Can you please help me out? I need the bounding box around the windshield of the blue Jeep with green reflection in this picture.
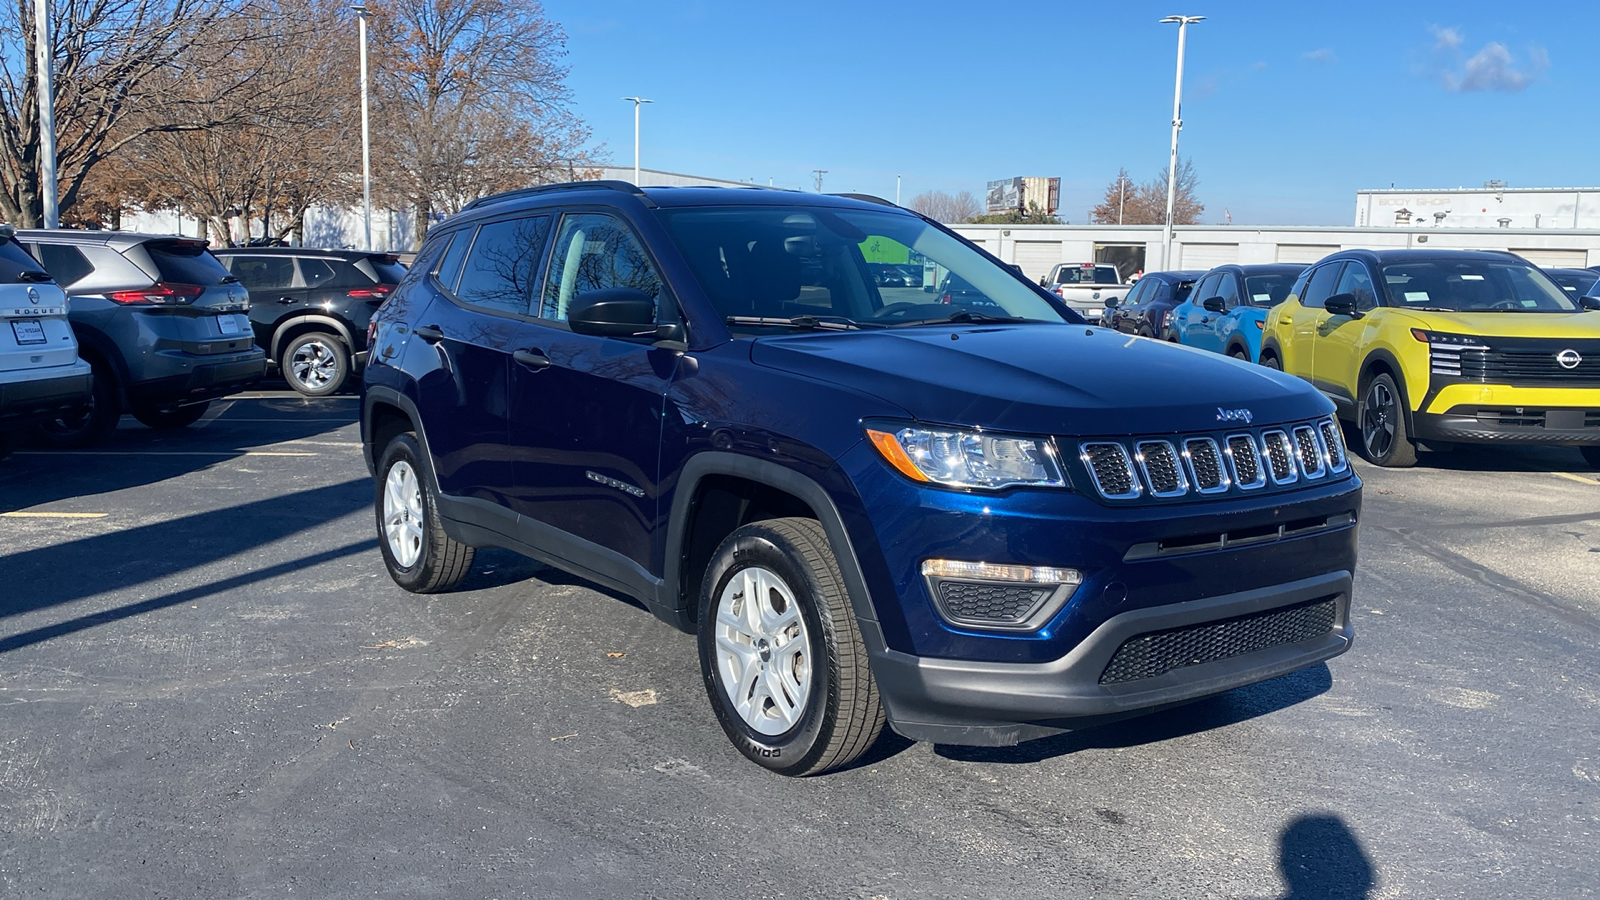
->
[661,207,1069,330]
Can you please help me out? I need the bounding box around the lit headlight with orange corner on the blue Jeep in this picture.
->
[867,426,1067,490]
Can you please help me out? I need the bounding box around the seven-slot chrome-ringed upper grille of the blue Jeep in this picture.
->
[1078,418,1350,501]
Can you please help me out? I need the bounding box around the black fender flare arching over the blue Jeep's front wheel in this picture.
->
[661,450,883,630]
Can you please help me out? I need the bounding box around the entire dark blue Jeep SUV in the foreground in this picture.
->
[362,181,1362,775]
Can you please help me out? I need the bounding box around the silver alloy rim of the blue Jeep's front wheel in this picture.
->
[717,567,811,735]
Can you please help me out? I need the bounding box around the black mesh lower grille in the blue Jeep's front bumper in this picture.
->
[1099,597,1338,684]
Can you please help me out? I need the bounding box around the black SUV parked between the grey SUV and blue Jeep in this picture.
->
[214,247,405,397]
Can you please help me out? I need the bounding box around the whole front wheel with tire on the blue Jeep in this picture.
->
[698,519,885,775]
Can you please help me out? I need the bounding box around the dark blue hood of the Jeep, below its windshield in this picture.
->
[750,325,1333,436]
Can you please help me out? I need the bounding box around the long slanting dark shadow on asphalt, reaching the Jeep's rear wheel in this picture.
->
[0,477,378,652]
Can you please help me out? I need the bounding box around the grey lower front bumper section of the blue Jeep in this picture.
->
[874,572,1354,746]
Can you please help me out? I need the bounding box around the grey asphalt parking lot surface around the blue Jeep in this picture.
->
[0,391,1600,900]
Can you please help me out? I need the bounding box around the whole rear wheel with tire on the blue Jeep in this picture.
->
[373,432,475,594]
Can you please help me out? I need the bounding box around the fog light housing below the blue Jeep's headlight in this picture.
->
[922,559,1083,631]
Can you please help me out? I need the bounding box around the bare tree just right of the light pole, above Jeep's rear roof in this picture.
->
[370,0,589,243]
